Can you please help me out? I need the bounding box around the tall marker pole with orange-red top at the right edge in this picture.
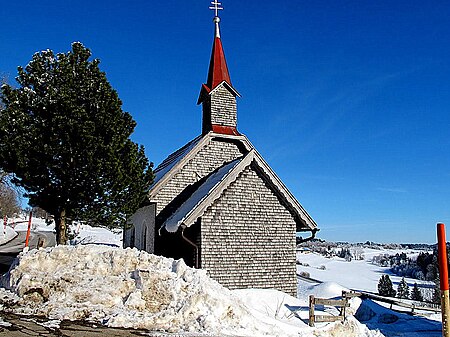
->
[437,223,450,337]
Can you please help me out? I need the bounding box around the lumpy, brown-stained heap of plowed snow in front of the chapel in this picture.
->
[0,245,264,333]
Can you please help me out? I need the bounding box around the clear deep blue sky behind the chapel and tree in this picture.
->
[0,0,450,243]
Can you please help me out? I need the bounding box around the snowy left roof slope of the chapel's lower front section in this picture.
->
[162,158,242,233]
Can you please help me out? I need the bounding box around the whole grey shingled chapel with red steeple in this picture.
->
[124,9,318,295]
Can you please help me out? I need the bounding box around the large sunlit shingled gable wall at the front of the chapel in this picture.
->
[201,166,297,296]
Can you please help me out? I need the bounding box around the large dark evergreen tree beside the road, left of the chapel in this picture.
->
[0,42,153,244]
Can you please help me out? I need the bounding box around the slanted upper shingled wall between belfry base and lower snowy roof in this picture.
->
[154,139,246,214]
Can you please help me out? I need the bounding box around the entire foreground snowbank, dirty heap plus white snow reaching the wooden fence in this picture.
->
[0,245,380,337]
